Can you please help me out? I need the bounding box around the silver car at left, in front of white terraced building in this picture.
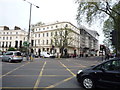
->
[2,51,23,62]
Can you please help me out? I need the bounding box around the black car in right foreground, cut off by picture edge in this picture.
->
[76,58,120,90]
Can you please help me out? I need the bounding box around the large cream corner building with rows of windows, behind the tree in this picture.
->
[31,22,80,54]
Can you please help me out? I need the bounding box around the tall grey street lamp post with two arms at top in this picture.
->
[24,0,39,60]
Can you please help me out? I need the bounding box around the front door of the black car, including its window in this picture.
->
[94,60,115,86]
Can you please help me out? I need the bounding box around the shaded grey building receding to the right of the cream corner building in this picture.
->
[80,27,99,56]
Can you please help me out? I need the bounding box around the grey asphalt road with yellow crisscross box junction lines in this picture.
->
[0,57,101,90]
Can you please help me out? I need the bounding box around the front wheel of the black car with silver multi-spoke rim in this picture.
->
[82,77,95,90]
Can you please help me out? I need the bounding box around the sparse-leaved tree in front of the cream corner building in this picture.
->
[52,27,74,57]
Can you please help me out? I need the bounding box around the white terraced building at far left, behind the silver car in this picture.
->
[0,26,27,51]
